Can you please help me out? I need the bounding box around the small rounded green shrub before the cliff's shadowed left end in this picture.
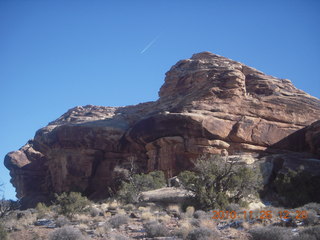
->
[56,192,90,218]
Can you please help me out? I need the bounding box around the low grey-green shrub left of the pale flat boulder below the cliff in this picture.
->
[117,171,166,203]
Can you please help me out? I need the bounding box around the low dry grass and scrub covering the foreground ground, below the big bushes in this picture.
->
[0,195,320,240]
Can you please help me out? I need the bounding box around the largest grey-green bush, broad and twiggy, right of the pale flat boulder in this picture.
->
[178,155,262,209]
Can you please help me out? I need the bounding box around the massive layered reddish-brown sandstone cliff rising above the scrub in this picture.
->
[5,52,320,206]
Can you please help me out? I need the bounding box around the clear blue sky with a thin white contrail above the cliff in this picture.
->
[0,0,320,198]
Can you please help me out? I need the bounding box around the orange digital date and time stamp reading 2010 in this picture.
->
[212,210,308,220]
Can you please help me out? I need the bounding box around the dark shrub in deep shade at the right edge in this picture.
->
[274,169,320,208]
